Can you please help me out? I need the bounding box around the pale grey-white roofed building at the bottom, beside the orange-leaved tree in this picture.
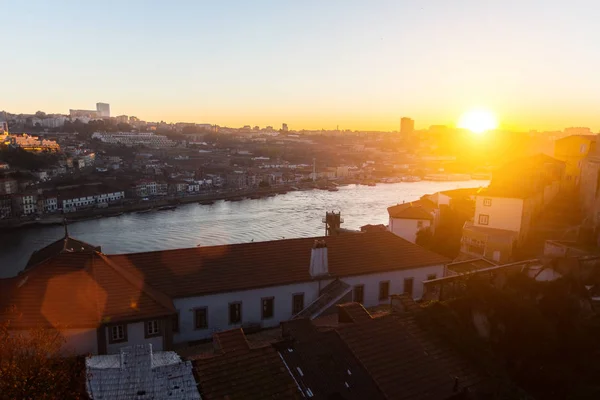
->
[85,345,200,400]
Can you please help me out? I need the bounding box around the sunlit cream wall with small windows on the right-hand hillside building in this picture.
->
[473,196,523,232]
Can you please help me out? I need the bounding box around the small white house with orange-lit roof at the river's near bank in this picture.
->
[388,199,439,243]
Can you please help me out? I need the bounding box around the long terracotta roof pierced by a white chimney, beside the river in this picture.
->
[107,232,450,298]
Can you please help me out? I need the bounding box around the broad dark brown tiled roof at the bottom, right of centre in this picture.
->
[336,308,480,400]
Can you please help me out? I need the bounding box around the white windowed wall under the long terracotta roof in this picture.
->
[173,265,444,343]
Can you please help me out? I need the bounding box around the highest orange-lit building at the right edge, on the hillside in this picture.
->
[554,135,596,190]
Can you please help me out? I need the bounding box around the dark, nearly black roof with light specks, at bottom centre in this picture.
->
[274,319,384,400]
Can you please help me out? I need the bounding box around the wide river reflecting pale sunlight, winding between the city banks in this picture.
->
[0,180,488,278]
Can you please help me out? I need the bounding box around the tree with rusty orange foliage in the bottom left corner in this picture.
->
[0,321,86,400]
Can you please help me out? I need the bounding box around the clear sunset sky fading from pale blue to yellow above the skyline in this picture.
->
[0,0,600,131]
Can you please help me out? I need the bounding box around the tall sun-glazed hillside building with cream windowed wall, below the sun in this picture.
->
[461,154,565,263]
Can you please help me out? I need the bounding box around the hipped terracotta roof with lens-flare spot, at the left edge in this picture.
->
[0,252,175,328]
